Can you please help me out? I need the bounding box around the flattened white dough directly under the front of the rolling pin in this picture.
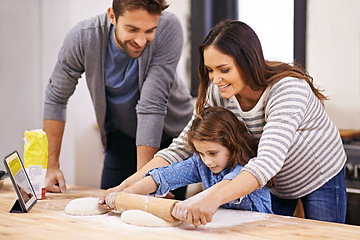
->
[121,209,182,227]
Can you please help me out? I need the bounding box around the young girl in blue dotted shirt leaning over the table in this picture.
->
[105,107,272,221]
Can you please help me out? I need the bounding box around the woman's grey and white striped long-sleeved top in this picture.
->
[156,77,346,199]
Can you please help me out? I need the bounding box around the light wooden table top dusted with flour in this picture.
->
[0,179,360,240]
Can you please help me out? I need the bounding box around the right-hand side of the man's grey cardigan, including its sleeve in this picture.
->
[136,12,193,147]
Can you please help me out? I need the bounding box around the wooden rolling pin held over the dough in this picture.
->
[115,192,179,222]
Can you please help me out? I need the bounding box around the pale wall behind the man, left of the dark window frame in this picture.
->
[0,0,190,187]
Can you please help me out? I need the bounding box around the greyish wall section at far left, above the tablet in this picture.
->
[0,0,43,169]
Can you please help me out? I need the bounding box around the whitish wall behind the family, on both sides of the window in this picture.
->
[0,0,360,187]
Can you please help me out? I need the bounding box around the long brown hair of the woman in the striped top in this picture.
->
[196,20,327,114]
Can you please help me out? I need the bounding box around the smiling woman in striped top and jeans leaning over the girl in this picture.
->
[100,20,346,224]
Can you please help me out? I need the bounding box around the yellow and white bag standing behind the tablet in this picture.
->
[24,129,48,199]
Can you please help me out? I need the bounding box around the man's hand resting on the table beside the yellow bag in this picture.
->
[46,168,66,193]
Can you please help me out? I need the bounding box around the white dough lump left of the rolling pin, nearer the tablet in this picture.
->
[64,197,108,216]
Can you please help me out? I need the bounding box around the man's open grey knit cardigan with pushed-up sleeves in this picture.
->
[44,12,194,147]
